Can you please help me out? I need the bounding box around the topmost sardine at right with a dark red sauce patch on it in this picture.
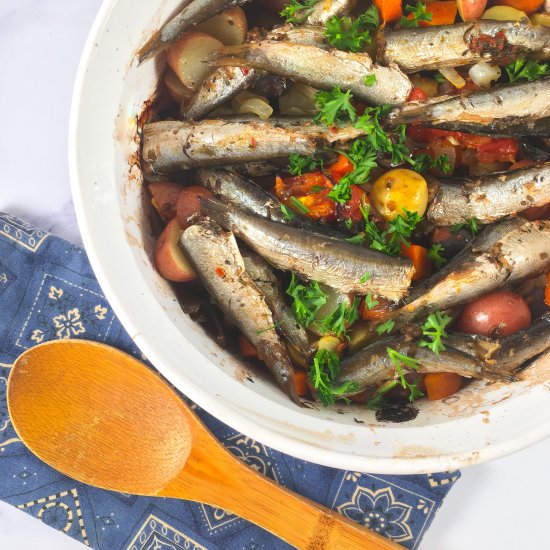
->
[376,20,550,73]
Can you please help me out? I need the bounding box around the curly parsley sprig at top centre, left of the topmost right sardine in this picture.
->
[325,6,380,52]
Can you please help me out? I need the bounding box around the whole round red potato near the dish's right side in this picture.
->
[458,290,531,338]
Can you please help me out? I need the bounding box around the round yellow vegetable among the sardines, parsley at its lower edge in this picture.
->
[369,168,428,221]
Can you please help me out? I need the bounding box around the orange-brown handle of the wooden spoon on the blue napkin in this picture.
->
[159,432,402,550]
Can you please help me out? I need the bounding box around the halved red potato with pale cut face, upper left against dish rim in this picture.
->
[167,31,223,91]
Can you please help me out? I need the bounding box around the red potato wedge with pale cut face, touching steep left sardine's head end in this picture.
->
[155,218,197,283]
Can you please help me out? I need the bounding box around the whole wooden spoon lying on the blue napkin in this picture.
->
[7,340,401,550]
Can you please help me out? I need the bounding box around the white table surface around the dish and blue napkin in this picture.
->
[0,0,550,550]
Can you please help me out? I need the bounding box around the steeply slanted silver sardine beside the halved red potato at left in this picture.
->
[180,221,300,403]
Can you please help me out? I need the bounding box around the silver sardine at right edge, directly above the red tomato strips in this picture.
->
[387,78,550,136]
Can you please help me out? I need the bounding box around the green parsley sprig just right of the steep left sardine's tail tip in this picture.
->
[309,349,359,406]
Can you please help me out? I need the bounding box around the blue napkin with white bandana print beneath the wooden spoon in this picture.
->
[0,214,460,550]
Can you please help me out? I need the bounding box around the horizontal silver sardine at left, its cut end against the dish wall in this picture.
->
[141,117,364,180]
